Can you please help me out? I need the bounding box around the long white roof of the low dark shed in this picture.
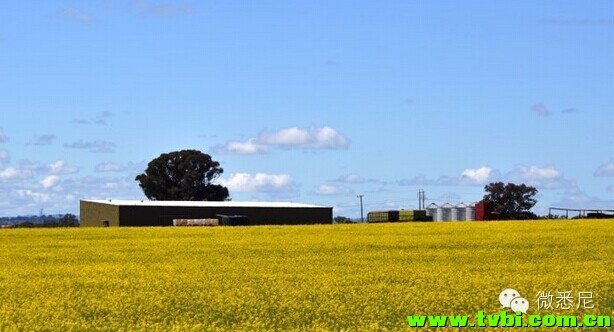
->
[81,199,330,208]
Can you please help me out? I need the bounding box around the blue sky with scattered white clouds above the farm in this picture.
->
[0,0,614,217]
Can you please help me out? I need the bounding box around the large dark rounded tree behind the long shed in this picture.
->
[135,150,229,201]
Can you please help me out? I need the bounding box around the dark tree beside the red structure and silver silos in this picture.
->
[482,182,537,219]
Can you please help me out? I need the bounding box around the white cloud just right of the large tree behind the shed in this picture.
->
[220,173,296,193]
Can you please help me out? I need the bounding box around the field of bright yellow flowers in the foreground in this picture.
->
[0,220,614,331]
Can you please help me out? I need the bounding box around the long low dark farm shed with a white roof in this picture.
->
[80,200,333,227]
